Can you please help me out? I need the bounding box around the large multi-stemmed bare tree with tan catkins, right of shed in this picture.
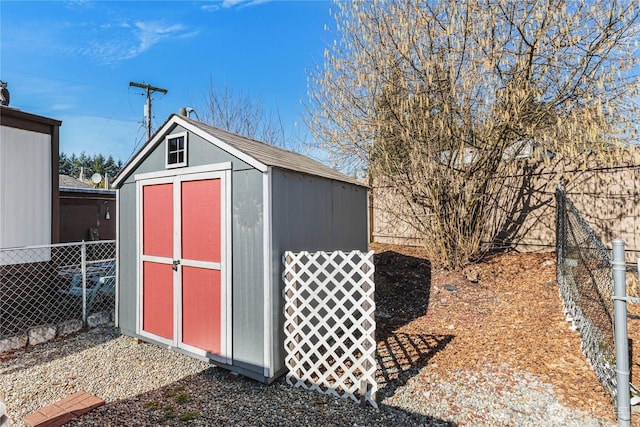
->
[309,0,640,268]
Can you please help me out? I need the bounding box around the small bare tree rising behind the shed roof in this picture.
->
[202,82,289,147]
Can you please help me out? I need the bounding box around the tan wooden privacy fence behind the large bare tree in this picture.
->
[369,164,640,262]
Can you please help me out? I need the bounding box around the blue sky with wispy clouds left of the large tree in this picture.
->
[0,0,333,161]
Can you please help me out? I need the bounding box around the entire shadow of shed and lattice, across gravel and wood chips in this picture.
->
[67,251,456,427]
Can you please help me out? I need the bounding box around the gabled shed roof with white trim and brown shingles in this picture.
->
[113,114,365,187]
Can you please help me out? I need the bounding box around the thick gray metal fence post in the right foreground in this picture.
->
[611,239,631,427]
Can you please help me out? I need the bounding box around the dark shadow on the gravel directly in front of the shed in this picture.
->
[66,367,455,427]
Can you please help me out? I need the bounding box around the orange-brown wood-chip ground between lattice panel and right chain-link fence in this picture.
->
[371,244,640,426]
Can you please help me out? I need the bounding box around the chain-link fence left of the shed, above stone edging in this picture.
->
[0,240,116,339]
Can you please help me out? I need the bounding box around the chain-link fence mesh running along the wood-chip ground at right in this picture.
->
[556,185,617,401]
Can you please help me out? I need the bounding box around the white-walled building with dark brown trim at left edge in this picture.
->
[0,105,62,256]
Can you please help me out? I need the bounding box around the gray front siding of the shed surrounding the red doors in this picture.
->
[118,126,264,375]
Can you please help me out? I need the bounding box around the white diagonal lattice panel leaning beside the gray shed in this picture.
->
[283,251,378,408]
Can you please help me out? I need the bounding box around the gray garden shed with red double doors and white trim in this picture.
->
[113,114,368,382]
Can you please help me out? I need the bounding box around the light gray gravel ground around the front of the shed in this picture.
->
[0,327,614,427]
